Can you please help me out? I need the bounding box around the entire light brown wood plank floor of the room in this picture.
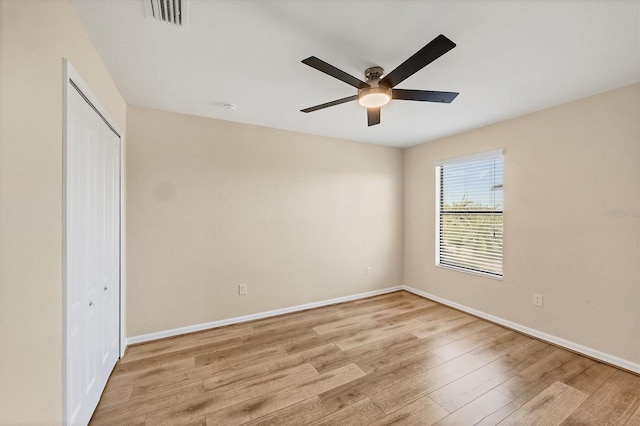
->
[91,291,640,426]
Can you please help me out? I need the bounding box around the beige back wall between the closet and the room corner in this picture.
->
[127,107,403,336]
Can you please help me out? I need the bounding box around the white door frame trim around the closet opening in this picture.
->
[62,58,126,425]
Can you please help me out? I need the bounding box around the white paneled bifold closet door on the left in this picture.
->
[65,80,120,424]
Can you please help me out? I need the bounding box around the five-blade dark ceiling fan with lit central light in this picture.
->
[300,34,458,126]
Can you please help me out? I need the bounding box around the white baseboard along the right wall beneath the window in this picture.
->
[401,285,640,374]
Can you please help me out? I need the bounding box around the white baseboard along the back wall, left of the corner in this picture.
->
[126,286,403,346]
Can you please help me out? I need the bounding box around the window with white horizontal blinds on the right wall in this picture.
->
[436,150,503,277]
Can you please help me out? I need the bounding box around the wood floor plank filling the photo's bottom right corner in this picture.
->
[565,370,640,425]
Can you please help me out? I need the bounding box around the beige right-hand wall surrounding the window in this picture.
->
[403,85,640,363]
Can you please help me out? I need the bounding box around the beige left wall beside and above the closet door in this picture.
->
[0,0,126,424]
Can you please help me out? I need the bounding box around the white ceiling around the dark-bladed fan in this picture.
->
[72,0,640,147]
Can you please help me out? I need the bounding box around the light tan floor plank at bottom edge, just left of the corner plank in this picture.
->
[500,382,589,426]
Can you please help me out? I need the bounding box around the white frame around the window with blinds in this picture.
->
[434,149,504,281]
